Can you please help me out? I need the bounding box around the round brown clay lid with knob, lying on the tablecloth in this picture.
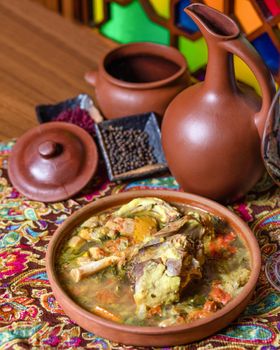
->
[8,122,98,202]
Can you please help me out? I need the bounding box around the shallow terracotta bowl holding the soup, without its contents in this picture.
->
[47,191,261,346]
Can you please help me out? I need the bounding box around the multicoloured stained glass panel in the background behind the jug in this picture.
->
[92,0,280,91]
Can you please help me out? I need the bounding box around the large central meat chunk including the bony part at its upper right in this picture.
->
[128,213,218,317]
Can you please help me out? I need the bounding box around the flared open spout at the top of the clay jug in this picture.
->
[185,4,240,41]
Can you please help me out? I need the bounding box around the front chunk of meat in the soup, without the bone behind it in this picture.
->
[128,234,201,313]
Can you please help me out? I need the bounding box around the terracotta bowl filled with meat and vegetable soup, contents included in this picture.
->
[47,191,260,346]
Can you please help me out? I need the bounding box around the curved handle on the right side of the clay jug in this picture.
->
[220,35,276,138]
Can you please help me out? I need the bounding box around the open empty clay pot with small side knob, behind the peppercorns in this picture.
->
[85,43,190,119]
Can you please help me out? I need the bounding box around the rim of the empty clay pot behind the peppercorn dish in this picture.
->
[99,42,188,89]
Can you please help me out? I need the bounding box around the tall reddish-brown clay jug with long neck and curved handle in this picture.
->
[162,4,275,202]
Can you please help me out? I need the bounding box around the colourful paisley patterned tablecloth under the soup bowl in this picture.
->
[0,141,280,350]
